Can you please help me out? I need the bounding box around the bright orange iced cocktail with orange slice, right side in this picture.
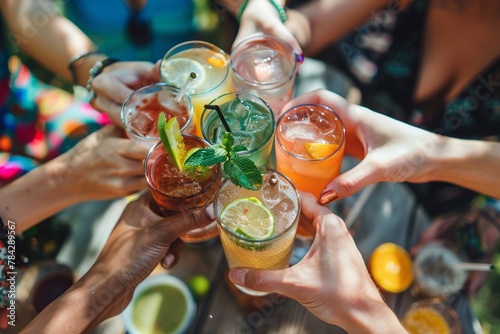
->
[275,104,345,198]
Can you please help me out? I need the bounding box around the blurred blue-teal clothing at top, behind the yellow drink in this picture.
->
[65,0,196,63]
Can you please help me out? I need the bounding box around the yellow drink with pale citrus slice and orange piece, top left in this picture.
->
[160,41,232,137]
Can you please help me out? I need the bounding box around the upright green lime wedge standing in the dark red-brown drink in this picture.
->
[158,112,185,170]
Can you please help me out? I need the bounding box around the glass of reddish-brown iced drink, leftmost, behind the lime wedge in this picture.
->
[121,83,194,147]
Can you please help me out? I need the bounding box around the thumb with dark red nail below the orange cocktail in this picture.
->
[319,159,382,204]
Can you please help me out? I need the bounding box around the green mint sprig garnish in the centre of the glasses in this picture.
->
[184,132,262,190]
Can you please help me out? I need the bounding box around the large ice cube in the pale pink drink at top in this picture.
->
[251,49,285,83]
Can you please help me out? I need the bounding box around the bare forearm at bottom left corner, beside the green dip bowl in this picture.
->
[22,267,131,333]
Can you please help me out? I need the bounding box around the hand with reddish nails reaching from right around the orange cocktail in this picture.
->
[282,89,442,204]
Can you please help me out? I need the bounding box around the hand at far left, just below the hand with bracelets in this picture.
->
[54,126,148,201]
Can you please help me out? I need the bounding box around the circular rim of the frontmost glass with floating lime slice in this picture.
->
[213,167,302,244]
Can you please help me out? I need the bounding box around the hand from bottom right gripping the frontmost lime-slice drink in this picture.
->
[229,193,399,333]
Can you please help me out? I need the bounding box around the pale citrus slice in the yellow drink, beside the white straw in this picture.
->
[161,58,206,89]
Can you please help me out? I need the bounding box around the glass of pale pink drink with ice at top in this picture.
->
[230,35,297,118]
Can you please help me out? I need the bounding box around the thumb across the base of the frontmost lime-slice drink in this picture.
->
[229,267,286,294]
